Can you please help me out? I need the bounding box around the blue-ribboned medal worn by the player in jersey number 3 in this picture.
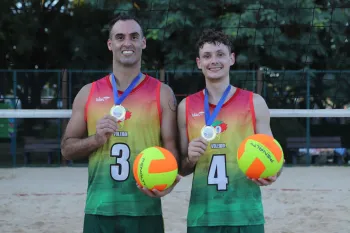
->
[110,72,142,121]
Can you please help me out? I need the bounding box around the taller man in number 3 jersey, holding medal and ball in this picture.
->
[62,16,179,233]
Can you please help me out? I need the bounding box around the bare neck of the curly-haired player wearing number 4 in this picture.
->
[205,78,235,104]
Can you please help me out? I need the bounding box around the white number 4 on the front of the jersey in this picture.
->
[208,155,228,191]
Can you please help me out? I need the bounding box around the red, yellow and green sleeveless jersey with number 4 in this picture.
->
[186,88,264,227]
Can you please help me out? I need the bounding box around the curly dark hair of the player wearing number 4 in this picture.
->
[197,29,233,53]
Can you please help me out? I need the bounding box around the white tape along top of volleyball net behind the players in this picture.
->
[0,109,350,119]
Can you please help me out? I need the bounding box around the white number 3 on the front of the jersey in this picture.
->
[111,143,130,181]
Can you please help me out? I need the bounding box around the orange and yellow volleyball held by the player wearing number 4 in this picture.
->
[237,134,284,179]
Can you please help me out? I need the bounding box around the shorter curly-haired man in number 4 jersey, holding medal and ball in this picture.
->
[178,30,284,233]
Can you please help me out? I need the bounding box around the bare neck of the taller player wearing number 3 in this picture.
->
[111,64,141,91]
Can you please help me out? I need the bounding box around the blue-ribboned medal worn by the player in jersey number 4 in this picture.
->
[201,85,231,141]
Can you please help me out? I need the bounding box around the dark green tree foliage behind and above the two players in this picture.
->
[0,0,350,111]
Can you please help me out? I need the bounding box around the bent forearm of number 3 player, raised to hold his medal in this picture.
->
[61,135,101,160]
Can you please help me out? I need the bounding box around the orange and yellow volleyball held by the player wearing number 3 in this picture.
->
[133,146,178,191]
